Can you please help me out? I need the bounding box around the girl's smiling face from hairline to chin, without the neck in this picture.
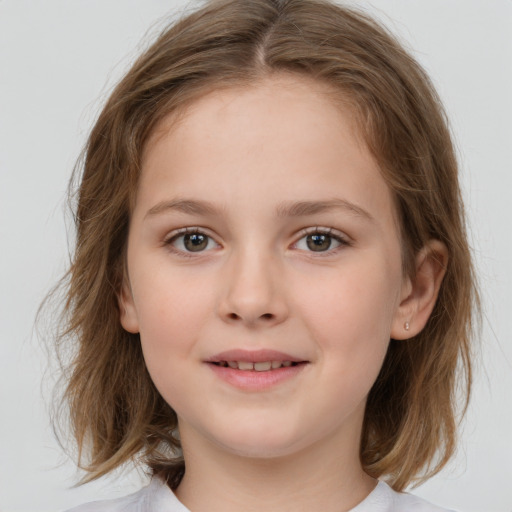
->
[121,77,409,457]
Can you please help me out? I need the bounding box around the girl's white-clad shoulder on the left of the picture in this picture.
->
[62,478,189,512]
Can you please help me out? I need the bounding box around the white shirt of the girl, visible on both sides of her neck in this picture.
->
[68,478,453,512]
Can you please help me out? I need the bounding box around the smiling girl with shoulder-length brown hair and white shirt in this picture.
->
[59,0,476,512]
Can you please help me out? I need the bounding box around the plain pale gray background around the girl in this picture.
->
[0,0,512,512]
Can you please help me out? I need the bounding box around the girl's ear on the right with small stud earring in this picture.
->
[391,240,448,340]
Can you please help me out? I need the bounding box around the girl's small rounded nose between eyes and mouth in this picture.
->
[219,248,288,328]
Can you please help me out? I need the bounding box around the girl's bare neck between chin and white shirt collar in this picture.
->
[176,422,376,512]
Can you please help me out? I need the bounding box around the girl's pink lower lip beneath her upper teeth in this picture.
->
[207,363,307,391]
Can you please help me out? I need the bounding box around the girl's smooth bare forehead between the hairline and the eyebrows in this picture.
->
[139,75,391,228]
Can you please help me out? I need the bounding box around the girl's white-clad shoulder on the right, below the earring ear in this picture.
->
[350,482,454,512]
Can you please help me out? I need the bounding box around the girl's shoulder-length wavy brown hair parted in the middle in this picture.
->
[58,0,478,490]
